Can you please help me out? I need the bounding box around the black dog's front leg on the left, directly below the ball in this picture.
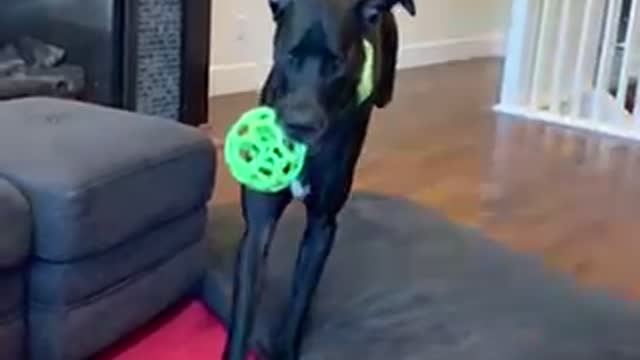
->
[222,189,291,360]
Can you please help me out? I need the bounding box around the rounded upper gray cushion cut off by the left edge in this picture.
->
[0,179,31,268]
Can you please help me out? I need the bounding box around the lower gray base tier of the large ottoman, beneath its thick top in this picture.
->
[29,241,206,360]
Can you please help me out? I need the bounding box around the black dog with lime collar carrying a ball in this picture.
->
[223,0,415,360]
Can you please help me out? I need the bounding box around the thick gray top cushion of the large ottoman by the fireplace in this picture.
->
[0,98,215,261]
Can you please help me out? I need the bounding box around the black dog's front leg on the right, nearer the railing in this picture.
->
[273,215,336,360]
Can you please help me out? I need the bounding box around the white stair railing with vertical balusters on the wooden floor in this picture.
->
[496,0,640,140]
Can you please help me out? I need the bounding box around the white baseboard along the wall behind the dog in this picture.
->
[209,33,504,96]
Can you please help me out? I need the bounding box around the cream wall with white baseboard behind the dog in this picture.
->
[211,0,511,95]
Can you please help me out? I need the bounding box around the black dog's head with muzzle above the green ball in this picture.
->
[262,0,415,146]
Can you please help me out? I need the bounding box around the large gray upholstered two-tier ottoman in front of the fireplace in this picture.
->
[0,98,216,360]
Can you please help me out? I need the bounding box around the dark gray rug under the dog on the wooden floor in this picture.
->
[202,194,640,360]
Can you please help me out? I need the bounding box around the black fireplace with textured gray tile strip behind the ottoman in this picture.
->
[0,0,210,125]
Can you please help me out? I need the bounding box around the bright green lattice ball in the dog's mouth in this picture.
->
[224,107,307,193]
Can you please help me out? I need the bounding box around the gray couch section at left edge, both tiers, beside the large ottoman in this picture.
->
[0,179,31,360]
